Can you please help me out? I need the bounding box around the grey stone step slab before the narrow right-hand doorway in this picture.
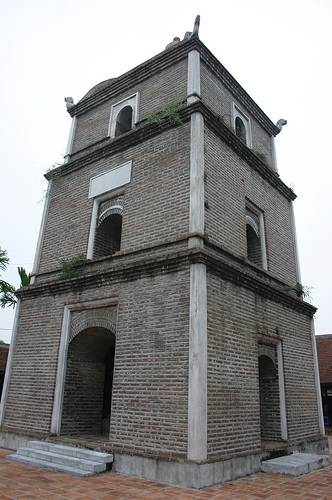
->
[261,453,330,476]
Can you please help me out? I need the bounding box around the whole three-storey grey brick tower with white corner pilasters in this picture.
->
[0,17,327,486]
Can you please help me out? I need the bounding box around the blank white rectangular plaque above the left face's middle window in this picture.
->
[89,161,132,198]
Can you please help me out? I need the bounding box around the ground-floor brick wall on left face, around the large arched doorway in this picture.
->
[4,269,189,456]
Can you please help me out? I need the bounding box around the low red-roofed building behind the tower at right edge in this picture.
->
[316,335,332,427]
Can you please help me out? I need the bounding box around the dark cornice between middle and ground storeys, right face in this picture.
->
[189,249,317,317]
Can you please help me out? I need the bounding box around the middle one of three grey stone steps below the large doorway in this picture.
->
[16,447,106,474]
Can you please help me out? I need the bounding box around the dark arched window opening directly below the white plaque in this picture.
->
[94,213,122,258]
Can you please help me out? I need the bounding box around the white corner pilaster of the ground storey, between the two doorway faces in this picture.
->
[188,263,207,460]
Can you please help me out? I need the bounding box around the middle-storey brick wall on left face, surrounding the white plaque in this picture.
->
[40,123,190,272]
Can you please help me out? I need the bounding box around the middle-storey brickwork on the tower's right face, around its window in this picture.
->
[205,127,296,286]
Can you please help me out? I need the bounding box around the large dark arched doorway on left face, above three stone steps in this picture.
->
[61,327,115,436]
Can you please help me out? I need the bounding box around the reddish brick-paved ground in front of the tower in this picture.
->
[0,438,332,500]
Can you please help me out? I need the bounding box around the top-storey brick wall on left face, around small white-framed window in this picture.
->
[73,59,187,152]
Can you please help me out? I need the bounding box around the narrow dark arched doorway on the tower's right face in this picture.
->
[258,355,281,441]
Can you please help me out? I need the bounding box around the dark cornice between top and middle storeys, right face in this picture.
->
[191,102,296,200]
